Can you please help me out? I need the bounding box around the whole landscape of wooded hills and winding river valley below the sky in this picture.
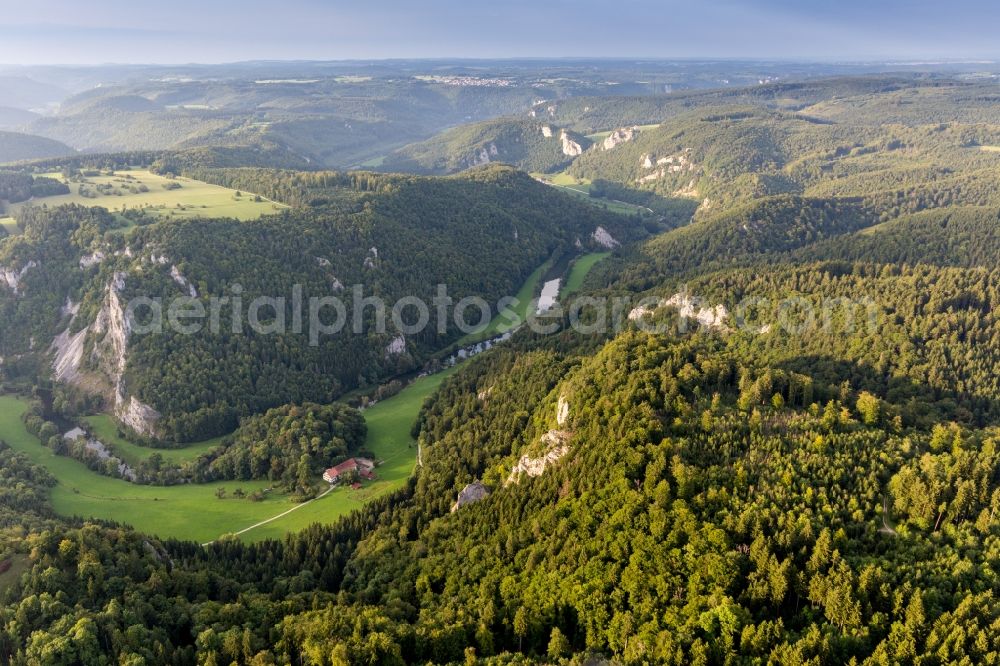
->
[0,59,1000,666]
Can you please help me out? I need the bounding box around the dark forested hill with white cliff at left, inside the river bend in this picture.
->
[0,166,638,440]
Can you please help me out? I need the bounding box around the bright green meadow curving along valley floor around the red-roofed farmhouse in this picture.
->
[0,370,453,543]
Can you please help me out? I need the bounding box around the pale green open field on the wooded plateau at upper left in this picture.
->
[10,170,286,220]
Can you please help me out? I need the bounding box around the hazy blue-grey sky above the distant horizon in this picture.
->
[0,0,1000,63]
